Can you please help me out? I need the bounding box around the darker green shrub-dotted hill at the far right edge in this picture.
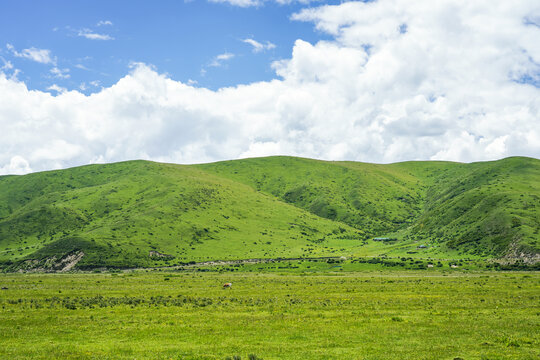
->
[402,158,540,256]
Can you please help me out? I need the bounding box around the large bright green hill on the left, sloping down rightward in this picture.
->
[0,161,365,267]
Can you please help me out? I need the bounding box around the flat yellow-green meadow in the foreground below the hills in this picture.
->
[0,265,540,360]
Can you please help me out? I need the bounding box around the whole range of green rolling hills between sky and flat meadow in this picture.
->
[0,156,540,269]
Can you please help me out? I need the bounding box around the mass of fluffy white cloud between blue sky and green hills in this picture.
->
[0,0,540,174]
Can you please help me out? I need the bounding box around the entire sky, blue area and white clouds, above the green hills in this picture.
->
[0,0,540,175]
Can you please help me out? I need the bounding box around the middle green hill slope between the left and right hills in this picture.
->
[198,156,460,236]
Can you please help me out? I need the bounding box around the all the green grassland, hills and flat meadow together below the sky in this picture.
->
[0,157,540,360]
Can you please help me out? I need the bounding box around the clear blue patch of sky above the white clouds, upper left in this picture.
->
[0,0,342,93]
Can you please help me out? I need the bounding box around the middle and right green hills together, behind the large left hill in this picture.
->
[199,157,540,257]
